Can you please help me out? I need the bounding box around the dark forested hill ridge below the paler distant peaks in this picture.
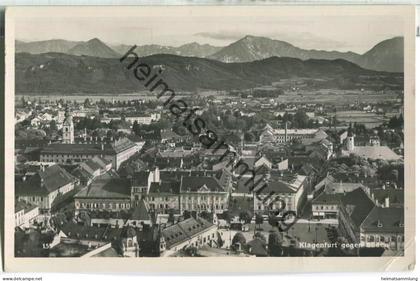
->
[15,53,403,94]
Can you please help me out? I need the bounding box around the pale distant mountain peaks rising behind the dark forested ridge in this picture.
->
[16,35,404,72]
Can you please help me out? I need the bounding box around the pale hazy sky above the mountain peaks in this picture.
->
[15,15,403,53]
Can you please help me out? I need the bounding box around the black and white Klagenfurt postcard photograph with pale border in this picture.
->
[5,4,414,270]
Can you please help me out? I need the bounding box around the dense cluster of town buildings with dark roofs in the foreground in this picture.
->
[15,95,404,257]
